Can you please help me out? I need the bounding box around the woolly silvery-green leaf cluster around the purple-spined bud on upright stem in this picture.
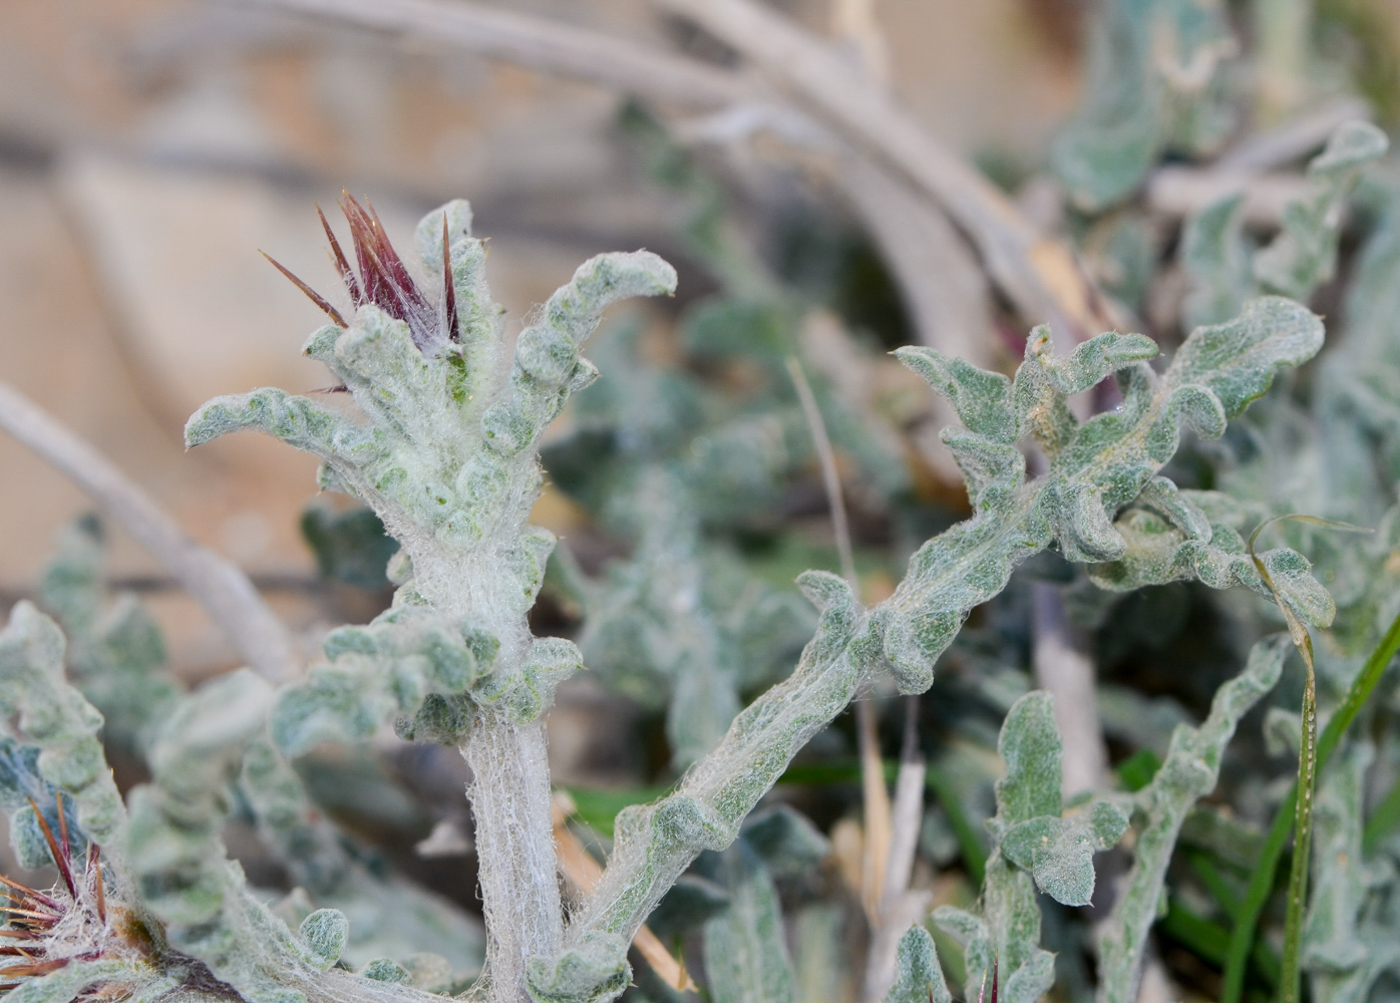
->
[186,202,676,795]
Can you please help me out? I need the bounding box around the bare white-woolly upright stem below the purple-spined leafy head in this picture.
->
[461,713,564,1003]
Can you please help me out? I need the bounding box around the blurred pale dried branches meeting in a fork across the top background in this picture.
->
[235,0,1112,340]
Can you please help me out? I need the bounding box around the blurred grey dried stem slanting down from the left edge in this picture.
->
[0,384,297,682]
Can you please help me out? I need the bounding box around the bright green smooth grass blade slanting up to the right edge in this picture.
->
[1221,607,1400,1003]
